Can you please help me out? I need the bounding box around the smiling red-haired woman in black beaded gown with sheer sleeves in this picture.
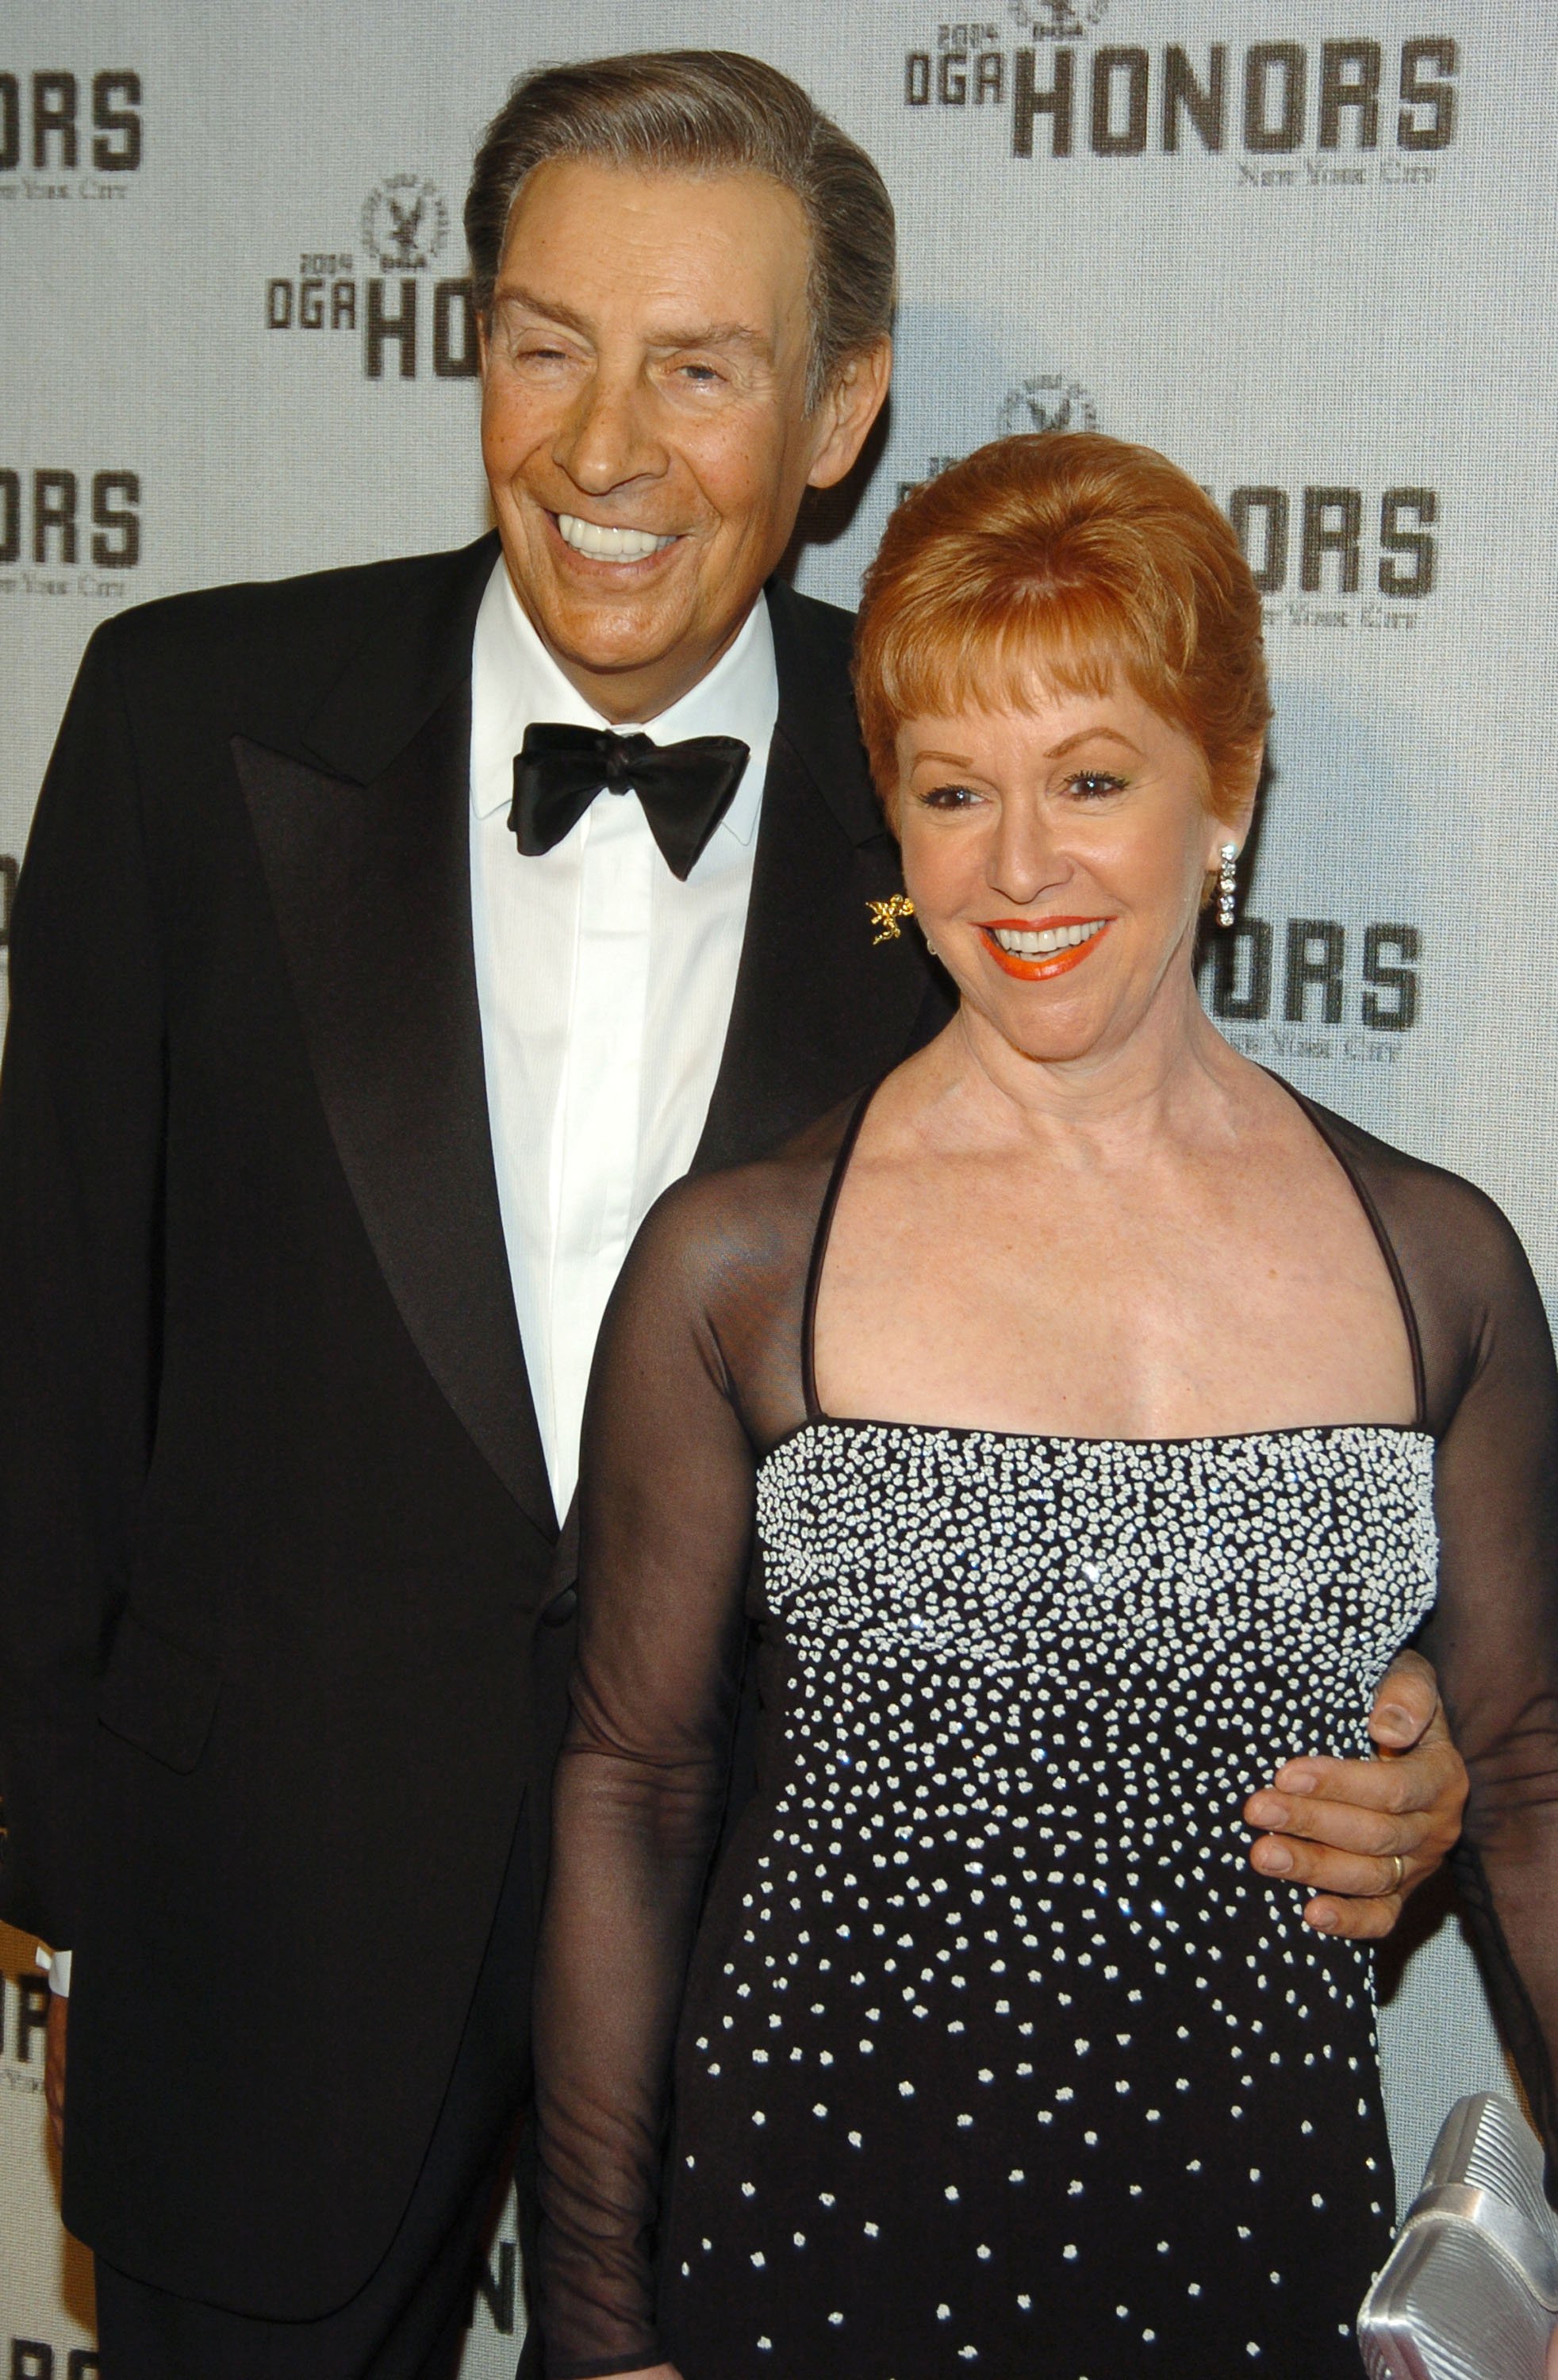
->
[538,438,1558,2380]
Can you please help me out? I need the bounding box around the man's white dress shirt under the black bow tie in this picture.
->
[471,559,778,1518]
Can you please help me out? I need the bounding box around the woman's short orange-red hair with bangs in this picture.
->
[854,431,1270,819]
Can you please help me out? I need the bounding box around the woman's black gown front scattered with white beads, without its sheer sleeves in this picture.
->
[669,1421,1437,2380]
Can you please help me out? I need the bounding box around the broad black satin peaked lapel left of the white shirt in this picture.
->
[233,681,557,1537]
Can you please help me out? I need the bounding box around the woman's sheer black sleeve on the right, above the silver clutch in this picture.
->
[1318,1119,1558,2202]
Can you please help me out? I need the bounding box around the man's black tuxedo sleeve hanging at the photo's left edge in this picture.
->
[0,624,164,1944]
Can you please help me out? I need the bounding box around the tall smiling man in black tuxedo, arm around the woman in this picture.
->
[0,55,1458,2380]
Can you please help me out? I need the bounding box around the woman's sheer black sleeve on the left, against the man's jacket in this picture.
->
[535,1128,837,2380]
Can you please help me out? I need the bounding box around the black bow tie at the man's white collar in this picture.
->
[509,724,747,883]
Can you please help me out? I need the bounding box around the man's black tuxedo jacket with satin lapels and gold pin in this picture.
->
[0,538,946,2318]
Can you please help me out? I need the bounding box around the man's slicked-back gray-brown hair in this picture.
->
[466,50,894,407]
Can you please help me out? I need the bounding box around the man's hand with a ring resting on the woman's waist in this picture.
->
[1244,1652,1468,1942]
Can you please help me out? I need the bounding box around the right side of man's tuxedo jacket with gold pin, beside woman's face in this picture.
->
[695,588,949,1171]
